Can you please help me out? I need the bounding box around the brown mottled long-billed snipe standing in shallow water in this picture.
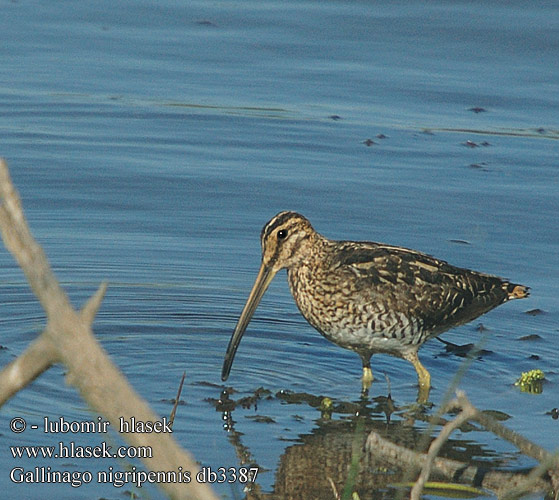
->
[221,212,529,398]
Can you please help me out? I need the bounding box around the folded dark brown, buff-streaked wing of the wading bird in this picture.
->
[331,242,507,331]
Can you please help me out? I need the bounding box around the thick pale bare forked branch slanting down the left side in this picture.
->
[0,160,217,500]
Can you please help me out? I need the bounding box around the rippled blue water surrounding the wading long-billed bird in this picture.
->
[0,0,559,498]
